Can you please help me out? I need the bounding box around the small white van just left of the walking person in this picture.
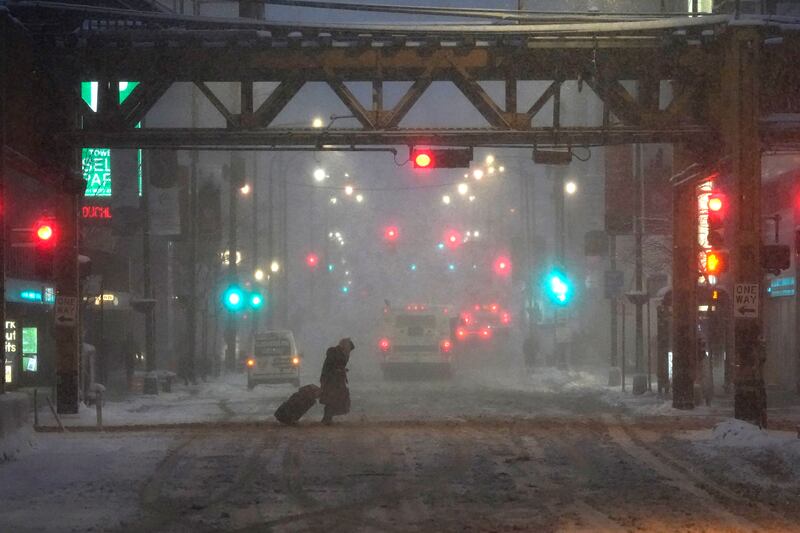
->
[246,330,302,389]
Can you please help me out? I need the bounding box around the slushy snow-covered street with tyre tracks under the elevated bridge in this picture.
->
[0,366,800,532]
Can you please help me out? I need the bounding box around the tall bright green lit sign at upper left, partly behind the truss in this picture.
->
[81,81,142,197]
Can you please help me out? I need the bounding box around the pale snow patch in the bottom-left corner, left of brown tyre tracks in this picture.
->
[0,433,173,533]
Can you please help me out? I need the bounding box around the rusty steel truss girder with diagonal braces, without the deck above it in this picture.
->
[61,38,711,147]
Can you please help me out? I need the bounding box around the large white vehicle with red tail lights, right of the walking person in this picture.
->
[378,304,453,378]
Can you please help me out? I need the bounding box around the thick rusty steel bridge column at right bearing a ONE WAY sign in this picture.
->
[720,28,767,427]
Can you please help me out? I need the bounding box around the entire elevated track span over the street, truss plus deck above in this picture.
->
[14,2,800,150]
